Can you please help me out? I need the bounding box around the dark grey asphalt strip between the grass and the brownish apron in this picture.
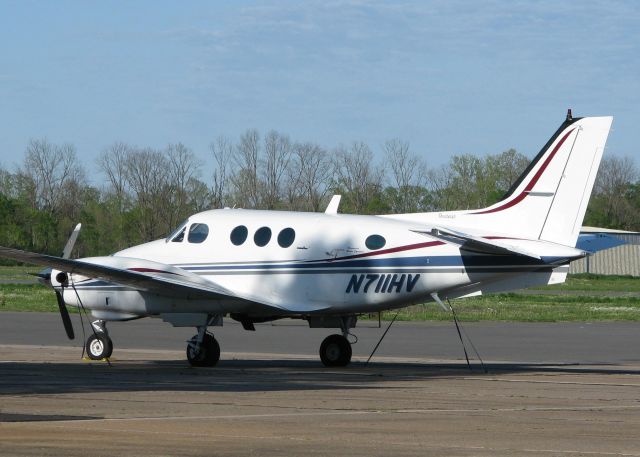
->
[0,312,640,364]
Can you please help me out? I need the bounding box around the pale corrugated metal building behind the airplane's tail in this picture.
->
[569,227,640,276]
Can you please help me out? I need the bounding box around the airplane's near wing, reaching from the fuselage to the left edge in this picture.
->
[0,246,322,313]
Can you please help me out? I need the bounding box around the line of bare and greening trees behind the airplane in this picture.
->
[0,129,640,256]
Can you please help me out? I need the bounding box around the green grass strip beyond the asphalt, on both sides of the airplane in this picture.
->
[0,266,640,322]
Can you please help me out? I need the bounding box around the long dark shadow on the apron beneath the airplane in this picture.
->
[0,360,640,396]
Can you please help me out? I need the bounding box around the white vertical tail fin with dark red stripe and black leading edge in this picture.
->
[464,114,613,246]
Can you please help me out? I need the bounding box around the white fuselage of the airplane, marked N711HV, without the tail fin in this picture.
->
[54,209,576,316]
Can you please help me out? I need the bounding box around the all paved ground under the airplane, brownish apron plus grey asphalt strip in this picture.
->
[0,313,640,456]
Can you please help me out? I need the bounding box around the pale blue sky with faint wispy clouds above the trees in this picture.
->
[0,0,640,176]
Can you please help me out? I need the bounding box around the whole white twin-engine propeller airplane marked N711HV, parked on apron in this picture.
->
[0,111,612,366]
